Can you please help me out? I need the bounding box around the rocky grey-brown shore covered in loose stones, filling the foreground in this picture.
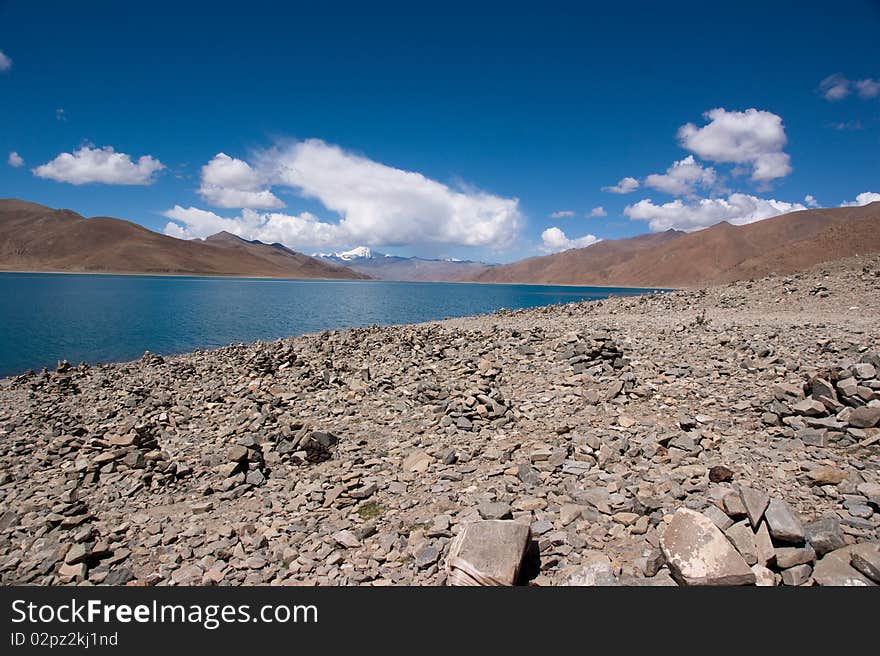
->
[0,257,880,585]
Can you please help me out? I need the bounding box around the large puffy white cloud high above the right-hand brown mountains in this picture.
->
[678,107,791,182]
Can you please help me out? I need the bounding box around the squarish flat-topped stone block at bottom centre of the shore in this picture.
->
[446,519,531,586]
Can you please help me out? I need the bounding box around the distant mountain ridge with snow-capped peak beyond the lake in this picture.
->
[313,246,494,282]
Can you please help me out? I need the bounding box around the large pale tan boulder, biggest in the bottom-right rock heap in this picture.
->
[660,508,755,585]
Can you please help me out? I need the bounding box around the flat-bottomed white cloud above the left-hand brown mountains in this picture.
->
[33,146,165,185]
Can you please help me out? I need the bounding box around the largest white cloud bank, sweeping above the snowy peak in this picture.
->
[165,139,522,249]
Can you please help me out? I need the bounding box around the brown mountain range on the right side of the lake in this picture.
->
[474,202,880,287]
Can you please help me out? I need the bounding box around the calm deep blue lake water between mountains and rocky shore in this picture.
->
[0,273,653,376]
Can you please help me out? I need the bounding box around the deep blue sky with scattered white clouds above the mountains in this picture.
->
[0,0,880,261]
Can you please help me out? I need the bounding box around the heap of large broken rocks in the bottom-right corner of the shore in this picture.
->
[658,486,880,586]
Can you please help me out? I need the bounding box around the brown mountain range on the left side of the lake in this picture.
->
[0,199,368,279]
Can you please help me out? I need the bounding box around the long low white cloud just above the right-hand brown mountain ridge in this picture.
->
[623,194,807,232]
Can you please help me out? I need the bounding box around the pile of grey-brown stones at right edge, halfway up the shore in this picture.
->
[762,353,880,447]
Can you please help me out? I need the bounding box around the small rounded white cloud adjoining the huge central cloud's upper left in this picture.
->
[199,153,284,209]
